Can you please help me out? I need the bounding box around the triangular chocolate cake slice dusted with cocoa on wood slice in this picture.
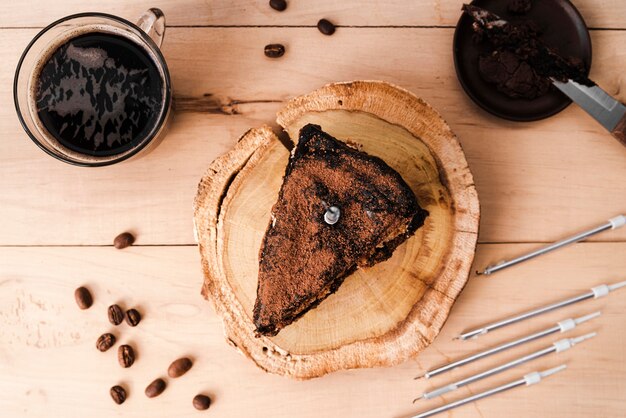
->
[254,125,428,336]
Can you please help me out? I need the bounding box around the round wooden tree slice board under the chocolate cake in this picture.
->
[194,82,479,379]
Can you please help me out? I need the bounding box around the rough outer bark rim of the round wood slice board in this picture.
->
[194,81,480,379]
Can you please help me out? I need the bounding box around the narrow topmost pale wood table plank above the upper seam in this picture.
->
[0,0,626,29]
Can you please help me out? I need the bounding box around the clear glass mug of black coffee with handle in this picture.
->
[13,9,172,167]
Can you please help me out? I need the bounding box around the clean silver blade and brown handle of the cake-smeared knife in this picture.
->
[552,80,626,145]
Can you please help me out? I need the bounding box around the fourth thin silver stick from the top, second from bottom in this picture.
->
[413,332,597,402]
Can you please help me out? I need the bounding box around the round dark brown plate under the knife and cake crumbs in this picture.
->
[453,0,591,121]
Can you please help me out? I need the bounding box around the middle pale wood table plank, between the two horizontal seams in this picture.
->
[0,28,626,245]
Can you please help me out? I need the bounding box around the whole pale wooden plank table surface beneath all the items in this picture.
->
[0,0,626,418]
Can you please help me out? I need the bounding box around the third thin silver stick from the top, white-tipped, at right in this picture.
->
[416,312,601,379]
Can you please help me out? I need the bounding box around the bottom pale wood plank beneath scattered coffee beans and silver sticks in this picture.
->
[0,243,626,418]
